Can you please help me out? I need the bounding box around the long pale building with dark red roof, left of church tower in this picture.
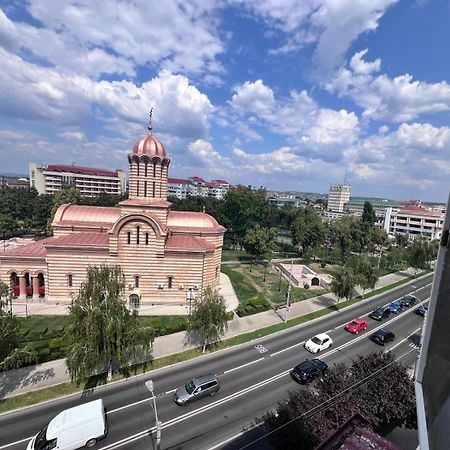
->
[28,162,126,197]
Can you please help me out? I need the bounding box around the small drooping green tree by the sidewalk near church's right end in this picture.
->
[187,286,228,353]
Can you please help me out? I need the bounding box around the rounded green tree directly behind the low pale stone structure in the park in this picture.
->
[291,208,325,256]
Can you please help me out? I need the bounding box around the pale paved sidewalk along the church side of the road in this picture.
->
[0,269,414,399]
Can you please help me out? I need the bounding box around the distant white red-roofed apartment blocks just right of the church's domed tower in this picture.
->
[167,176,233,200]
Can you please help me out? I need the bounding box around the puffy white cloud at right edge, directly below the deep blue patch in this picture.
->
[325,50,450,122]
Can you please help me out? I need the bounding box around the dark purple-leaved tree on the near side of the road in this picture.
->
[263,352,417,450]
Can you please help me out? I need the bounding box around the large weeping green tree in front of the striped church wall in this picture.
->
[66,265,153,383]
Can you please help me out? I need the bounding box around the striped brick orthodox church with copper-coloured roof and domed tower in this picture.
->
[0,121,225,308]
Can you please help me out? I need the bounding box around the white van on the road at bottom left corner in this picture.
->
[27,399,108,450]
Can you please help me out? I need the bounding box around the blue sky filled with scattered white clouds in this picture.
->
[0,0,450,202]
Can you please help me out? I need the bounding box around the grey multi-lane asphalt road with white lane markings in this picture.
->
[0,275,432,450]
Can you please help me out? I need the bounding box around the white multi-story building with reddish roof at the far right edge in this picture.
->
[385,205,445,239]
